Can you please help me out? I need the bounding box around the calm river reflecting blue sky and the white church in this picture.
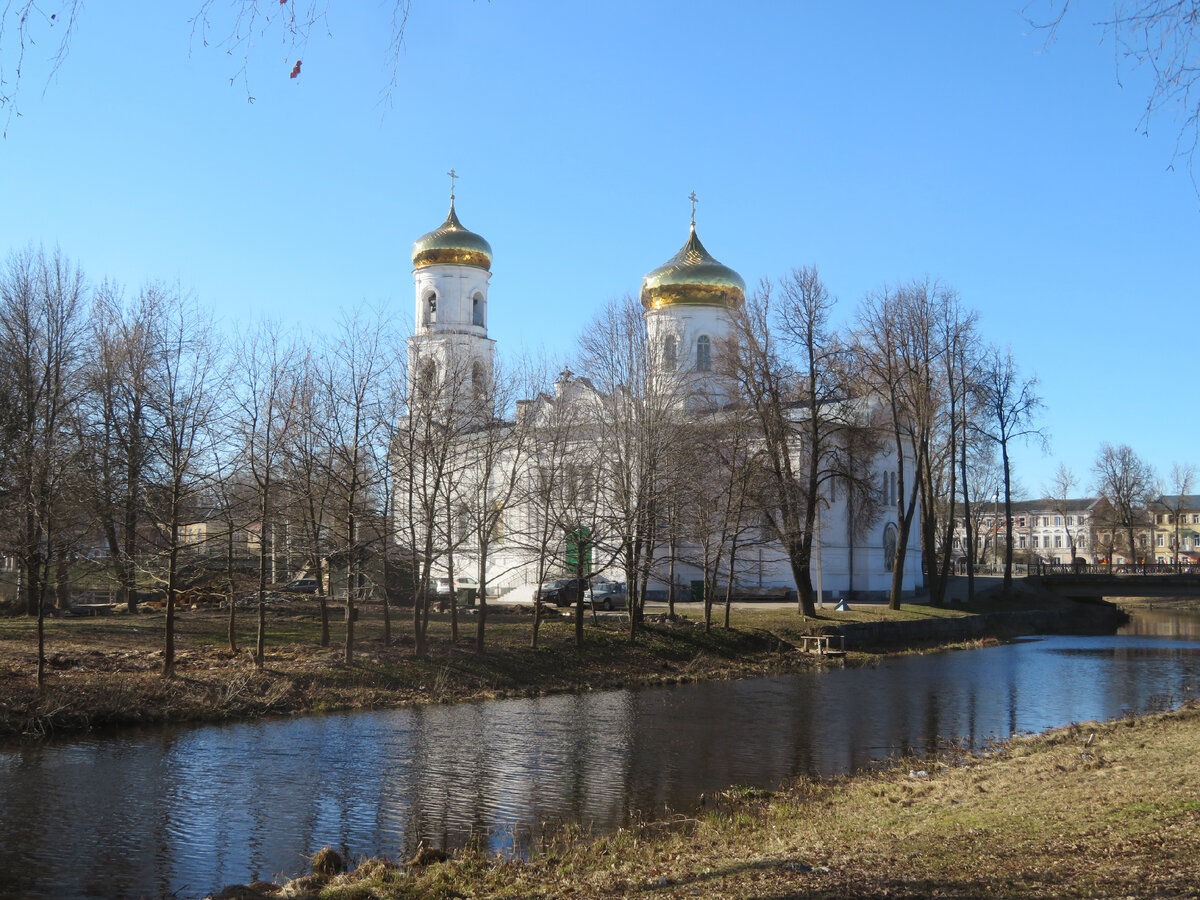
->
[0,611,1200,898]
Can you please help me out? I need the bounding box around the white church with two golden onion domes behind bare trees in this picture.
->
[396,193,922,601]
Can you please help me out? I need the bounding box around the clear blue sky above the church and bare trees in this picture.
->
[0,0,1200,496]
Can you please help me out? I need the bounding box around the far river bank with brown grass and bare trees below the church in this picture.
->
[0,585,1111,738]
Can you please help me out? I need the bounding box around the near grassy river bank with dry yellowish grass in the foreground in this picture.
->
[212,703,1200,900]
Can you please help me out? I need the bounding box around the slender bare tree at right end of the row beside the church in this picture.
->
[976,348,1045,598]
